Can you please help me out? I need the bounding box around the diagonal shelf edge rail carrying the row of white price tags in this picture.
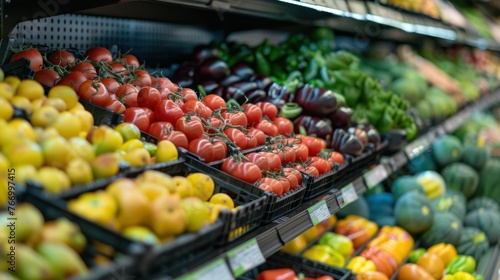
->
[173,90,500,279]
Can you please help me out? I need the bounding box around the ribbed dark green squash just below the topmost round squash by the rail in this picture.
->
[441,162,479,198]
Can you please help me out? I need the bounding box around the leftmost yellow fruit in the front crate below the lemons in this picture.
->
[68,191,118,226]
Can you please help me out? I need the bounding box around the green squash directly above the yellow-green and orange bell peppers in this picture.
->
[421,212,462,248]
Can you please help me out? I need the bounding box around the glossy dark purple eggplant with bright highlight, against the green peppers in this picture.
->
[294,85,337,117]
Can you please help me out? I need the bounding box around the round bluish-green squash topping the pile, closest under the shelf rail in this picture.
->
[432,135,463,166]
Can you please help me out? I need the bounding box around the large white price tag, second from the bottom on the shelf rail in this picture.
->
[228,238,266,279]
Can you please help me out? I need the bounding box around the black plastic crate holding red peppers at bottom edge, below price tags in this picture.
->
[237,252,352,280]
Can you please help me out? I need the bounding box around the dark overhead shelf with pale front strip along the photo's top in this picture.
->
[1,0,500,53]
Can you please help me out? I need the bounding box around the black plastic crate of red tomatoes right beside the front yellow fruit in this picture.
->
[187,157,306,223]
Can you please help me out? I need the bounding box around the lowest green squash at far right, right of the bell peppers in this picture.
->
[457,227,490,260]
